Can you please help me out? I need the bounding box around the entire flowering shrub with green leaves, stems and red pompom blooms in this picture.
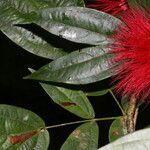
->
[0,0,150,150]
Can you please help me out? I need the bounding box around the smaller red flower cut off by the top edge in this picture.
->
[86,0,128,16]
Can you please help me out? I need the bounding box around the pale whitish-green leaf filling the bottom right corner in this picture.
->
[99,128,150,150]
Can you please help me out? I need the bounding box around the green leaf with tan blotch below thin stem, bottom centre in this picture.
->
[61,122,99,150]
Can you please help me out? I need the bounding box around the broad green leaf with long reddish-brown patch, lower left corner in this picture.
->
[0,105,49,150]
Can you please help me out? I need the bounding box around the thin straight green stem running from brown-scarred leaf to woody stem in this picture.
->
[44,116,122,129]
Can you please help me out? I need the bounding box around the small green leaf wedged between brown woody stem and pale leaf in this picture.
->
[109,117,126,142]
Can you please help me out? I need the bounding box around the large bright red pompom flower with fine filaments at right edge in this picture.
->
[111,9,150,100]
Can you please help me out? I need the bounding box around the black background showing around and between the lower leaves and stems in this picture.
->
[0,32,150,150]
